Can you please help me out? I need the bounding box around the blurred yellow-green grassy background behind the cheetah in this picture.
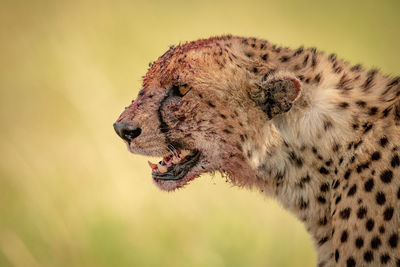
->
[0,0,400,267]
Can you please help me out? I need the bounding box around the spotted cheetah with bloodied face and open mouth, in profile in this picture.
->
[114,36,400,266]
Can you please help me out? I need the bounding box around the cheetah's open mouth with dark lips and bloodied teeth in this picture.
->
[148,150,200,183]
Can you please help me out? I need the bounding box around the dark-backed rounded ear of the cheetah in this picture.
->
[249,72,301,119]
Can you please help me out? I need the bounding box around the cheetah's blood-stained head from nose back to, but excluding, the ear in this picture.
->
[114,36,300,191]
